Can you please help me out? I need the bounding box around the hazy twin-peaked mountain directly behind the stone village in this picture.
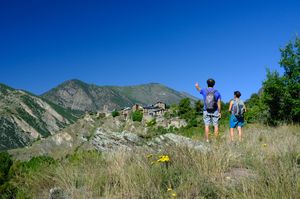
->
[42,80,196,111]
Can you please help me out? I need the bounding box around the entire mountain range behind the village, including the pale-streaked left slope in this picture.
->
[0,80,196,151]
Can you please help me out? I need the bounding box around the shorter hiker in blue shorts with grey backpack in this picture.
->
[228,91,246,141]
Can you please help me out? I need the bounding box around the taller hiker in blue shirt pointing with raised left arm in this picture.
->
[195,79,221,142]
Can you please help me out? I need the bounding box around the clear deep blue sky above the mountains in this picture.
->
[0,0,300,101]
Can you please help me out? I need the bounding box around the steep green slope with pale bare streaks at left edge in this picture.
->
[0,84,77,150]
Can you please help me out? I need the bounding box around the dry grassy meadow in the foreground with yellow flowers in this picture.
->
[14,126,300,199]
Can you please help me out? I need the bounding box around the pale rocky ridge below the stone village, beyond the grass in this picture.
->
[10,115,208,160]
